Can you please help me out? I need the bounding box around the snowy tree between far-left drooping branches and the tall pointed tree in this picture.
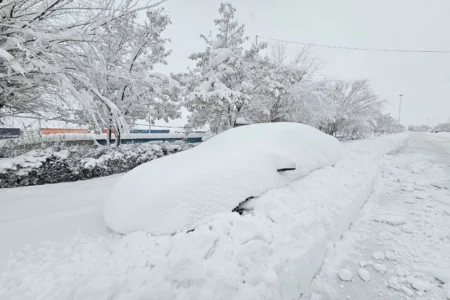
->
[74,9,178,144]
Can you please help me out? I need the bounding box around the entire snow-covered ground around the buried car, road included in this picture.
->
[0,135,450,299]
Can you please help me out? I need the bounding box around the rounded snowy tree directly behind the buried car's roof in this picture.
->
[249,42,324,123]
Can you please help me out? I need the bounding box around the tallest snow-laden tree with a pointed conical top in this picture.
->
[186,3,265,132]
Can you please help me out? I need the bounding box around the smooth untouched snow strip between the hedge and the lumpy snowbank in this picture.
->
[0,175,121,273]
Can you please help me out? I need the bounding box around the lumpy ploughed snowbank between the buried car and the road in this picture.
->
[0,135,407,300]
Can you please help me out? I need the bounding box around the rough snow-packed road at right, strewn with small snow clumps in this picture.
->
[302,134,450,300]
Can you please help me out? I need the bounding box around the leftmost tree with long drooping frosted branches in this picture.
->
[0,0,167,135]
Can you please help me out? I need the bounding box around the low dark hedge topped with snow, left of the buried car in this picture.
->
[0,142,192,188]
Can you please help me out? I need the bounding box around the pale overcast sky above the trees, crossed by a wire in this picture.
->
[152,0,450,125]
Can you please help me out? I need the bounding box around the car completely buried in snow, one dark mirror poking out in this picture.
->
[104,123,340,235]
